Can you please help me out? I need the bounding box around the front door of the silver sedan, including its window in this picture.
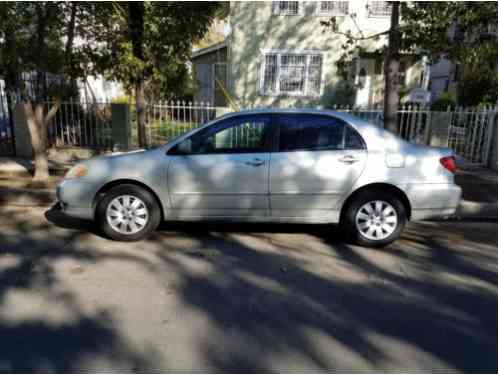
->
[168,115,271,217]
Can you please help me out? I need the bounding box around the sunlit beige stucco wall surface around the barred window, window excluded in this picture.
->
[228,0,422,107]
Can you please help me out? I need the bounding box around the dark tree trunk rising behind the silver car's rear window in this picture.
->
[384,1,401,134]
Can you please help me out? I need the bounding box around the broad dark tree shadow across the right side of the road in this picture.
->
[150,223,498,372]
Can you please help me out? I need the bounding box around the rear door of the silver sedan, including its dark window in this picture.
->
[270,114,366,220]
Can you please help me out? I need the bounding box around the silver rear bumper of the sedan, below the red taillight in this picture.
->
[402,184,462,221]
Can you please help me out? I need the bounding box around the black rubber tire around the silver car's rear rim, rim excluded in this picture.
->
[341,190,407,247]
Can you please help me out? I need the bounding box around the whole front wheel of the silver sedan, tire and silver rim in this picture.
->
[97,184,161,241]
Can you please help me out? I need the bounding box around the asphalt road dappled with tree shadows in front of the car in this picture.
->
[0,207,498,372]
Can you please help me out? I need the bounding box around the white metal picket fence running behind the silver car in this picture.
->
[43,101,498,165]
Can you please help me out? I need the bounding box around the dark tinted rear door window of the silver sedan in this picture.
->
[278,114,346,151]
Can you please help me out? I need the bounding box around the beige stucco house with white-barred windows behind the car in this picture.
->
[193,0,427,107]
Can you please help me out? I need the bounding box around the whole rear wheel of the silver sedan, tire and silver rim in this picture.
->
[342,191,406,247]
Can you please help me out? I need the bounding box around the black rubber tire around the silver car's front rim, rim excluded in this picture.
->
[95,184,161,242]
